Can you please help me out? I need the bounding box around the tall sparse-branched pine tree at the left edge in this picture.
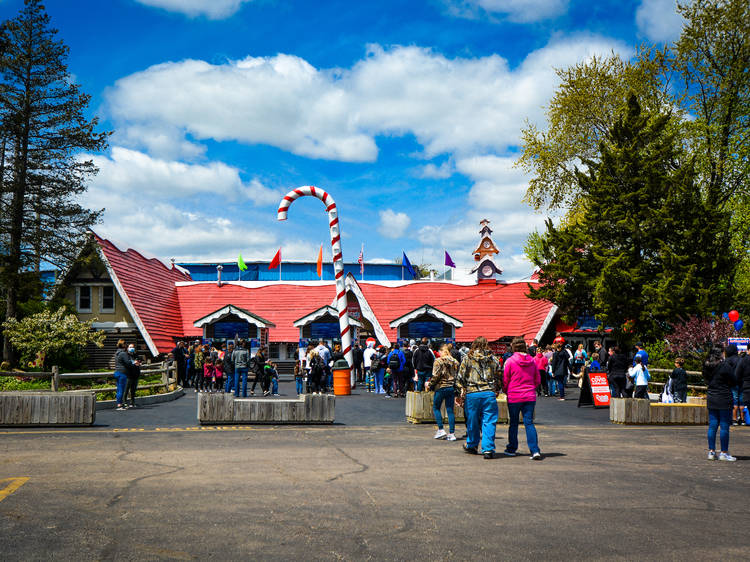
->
[0,0,108,359]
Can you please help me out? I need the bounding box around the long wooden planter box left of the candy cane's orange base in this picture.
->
[198,392,336,424]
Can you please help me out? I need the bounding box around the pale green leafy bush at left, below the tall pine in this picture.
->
[3,308,105,367]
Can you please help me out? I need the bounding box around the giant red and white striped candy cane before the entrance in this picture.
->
[277,185,354,367]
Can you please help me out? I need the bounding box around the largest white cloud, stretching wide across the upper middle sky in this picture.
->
[107,35,629,162]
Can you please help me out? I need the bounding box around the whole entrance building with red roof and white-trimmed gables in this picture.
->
[65,223,557,363]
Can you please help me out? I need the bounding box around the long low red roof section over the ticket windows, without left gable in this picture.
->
[177,282,552,342]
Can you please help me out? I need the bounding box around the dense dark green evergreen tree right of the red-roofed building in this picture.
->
[531,93,733,341]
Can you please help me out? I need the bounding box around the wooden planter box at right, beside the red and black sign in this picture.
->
[609,398,708,425]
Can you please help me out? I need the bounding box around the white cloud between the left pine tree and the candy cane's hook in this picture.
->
[88,146,283,208]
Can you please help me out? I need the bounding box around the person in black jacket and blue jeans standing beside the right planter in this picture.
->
[703,344,738,461]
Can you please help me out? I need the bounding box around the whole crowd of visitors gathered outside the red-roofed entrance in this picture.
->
[131,334,750,461]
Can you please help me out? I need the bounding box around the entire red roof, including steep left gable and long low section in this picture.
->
[94,235,553,354]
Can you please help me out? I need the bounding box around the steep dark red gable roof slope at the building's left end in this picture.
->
[94,234,191,355]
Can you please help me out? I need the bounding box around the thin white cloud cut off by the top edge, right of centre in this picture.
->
[445,0,569,23]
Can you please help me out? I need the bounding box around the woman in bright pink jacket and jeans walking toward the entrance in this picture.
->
[503,338,542,460]
